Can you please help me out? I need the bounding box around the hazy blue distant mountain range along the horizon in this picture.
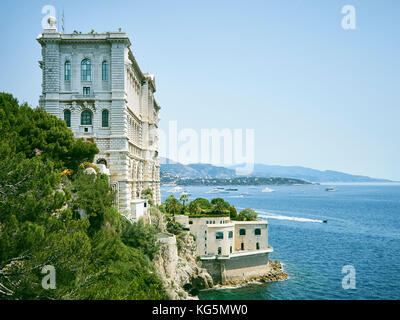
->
[160,158,391,183]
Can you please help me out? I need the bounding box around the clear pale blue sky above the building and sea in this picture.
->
[0,0,400,180]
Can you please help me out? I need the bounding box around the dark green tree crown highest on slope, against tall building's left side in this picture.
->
[0,93,99,170]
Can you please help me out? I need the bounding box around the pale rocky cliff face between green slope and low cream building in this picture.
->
[150,208,214,300]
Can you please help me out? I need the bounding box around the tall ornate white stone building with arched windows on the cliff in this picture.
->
[37,18,161,221]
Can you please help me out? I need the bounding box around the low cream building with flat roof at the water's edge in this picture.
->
[175,215,273,284]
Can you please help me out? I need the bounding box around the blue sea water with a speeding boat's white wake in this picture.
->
[162,185,400,300]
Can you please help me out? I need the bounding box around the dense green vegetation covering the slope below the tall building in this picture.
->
[0,93,166,300]
